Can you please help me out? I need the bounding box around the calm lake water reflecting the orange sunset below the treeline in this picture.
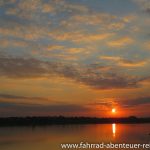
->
[0,124,150,150]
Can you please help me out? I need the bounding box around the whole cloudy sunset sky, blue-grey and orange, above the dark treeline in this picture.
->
[0,0,150,117]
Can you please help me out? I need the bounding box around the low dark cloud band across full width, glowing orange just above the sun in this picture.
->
[0,94,150,116]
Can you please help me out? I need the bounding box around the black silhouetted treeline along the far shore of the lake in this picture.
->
[0,116,150,126]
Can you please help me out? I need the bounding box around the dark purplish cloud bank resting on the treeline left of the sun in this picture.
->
[0,102,89,116]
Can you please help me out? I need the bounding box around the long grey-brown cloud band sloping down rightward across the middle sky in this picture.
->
[0,57,142,89]
